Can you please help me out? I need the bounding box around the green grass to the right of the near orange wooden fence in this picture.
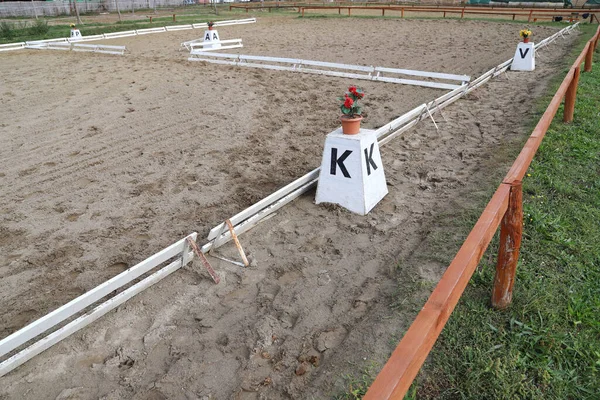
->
[412,35,600,399]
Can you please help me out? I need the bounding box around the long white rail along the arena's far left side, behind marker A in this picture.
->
[0,18,256,52]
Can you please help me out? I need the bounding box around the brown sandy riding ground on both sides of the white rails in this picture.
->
[0,17,576,399]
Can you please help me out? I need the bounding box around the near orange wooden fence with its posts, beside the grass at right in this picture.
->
[364,27,600,400]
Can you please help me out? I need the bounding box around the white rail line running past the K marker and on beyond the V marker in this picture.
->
[201,22,579,253]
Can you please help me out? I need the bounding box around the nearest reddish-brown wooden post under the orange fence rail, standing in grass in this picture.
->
[492,181,523,310]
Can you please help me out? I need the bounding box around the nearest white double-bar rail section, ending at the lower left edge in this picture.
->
[0,232,198,377]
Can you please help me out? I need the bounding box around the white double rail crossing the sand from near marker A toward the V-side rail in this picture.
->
[188,49,471,90]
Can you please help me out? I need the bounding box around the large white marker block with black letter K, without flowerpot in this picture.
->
[316,128,388,215]
